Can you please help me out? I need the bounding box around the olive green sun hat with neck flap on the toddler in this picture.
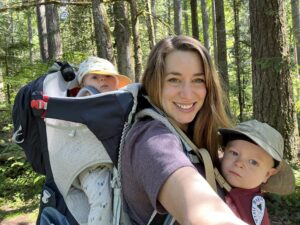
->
[219,120,295,195]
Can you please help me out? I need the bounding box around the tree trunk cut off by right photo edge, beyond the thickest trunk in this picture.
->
[291,0,300,75]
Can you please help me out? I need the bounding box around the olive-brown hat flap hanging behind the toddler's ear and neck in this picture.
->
[261,160,296,195]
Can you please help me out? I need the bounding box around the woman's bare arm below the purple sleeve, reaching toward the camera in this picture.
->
[158,167,246,225]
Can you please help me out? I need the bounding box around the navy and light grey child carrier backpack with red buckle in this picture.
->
[13,63,226,225]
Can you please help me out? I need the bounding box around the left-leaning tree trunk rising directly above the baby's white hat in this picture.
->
[92,0,115,64]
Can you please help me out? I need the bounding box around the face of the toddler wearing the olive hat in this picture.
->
[221,140,276,189]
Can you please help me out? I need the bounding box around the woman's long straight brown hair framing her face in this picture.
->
[141,36,231,164]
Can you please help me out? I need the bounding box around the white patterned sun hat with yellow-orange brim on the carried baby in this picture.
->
[77,56,131,89]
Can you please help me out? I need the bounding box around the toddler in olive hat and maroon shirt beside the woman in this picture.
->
[219,120,295,225]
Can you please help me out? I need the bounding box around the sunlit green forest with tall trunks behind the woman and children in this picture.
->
[0,0,300,224]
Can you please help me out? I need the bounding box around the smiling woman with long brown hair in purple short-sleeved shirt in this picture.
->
[121,36,245,225]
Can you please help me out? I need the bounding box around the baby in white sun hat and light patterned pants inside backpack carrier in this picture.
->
[64,56,131,225]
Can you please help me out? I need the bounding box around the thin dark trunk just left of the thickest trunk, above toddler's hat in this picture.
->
[233,0,245,121]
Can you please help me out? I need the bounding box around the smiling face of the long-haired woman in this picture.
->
[162,50,206,131]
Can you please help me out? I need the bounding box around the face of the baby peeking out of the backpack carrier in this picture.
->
[82,74,117,93]
